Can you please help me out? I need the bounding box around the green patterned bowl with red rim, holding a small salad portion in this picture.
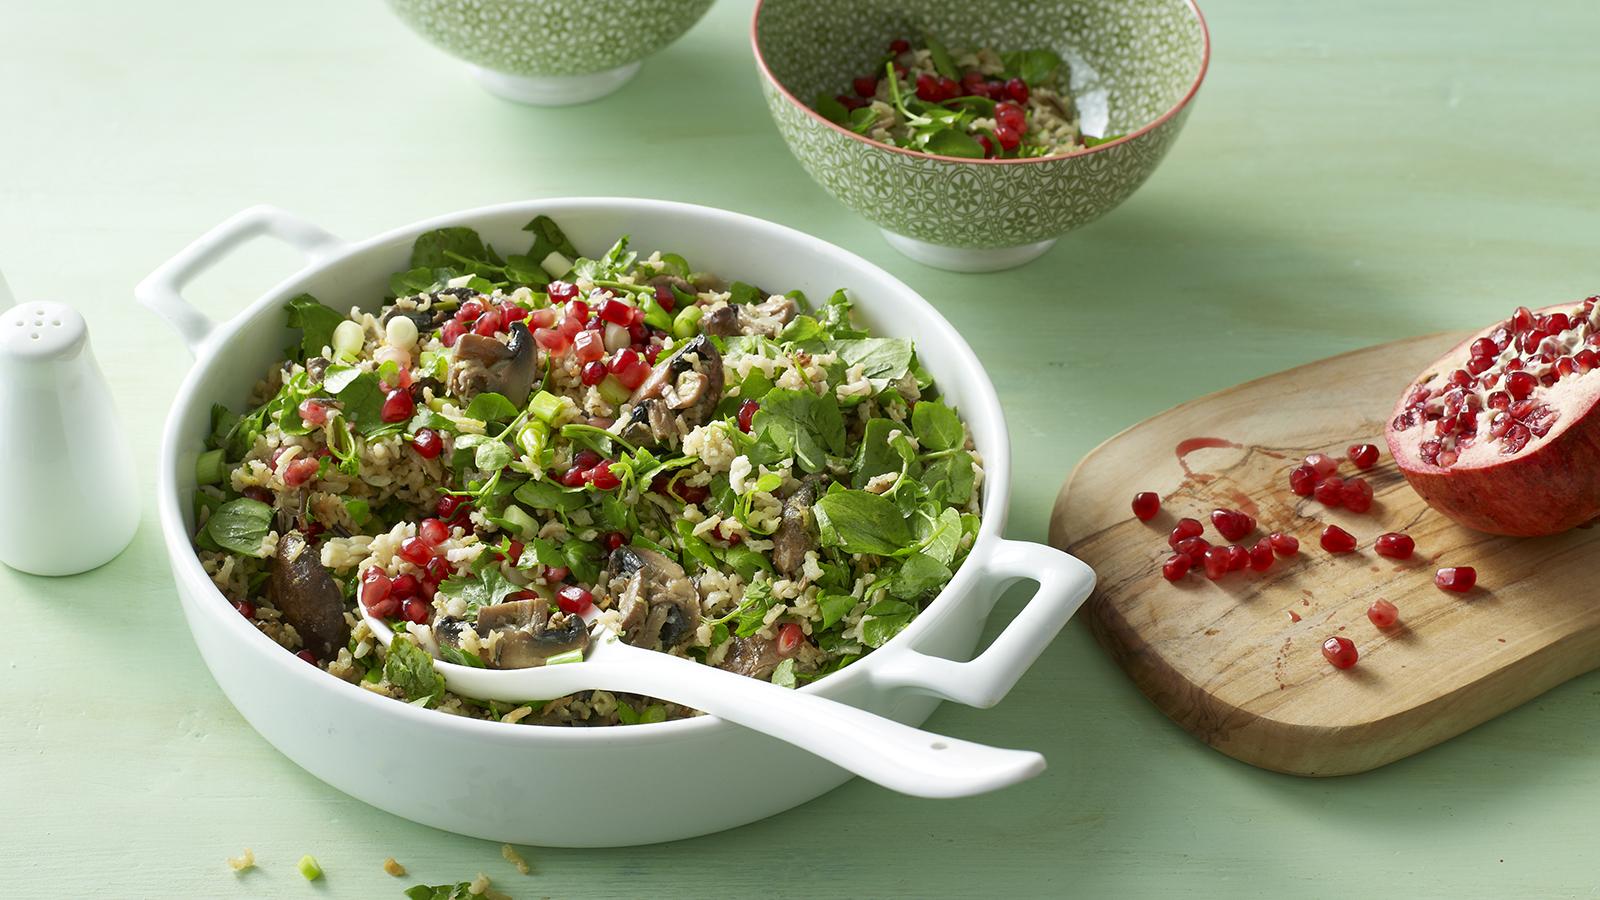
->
[750,0,1211,272]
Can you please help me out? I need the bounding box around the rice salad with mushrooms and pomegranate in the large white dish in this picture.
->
[195,216,984,725]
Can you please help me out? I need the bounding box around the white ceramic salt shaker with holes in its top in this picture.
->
[0,269,139,575]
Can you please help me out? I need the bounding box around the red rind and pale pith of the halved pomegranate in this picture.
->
[1384,303,1600,536]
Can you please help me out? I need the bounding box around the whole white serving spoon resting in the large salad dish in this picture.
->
[357,604,1045,798]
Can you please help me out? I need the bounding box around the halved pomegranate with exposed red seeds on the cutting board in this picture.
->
[1384,296,1600,536]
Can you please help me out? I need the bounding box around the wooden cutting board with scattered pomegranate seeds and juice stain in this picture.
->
[1050,335,1600,775]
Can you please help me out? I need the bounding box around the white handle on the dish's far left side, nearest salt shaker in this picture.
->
[133,207,344,356]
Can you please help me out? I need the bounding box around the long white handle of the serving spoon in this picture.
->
[590,650,1045,798]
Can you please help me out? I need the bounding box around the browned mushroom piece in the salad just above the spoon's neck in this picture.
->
[606,544,699,650]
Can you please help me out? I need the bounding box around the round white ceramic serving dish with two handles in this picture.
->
[136,199,1094,847]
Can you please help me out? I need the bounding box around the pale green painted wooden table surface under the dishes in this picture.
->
[0,0,1600,897]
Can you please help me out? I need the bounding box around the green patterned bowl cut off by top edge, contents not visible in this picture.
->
[389,0,712,106]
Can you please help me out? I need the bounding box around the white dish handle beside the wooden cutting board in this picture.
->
[874,540,1094,708]
